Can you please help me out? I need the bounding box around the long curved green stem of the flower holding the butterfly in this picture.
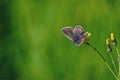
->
[86,43,118,80]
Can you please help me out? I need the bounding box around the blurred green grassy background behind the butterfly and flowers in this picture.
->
[0,0,120,80]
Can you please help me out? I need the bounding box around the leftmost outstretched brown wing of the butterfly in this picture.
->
[61,27,74,41]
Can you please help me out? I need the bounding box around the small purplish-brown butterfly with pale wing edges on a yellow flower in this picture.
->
[61,25,88,46]
